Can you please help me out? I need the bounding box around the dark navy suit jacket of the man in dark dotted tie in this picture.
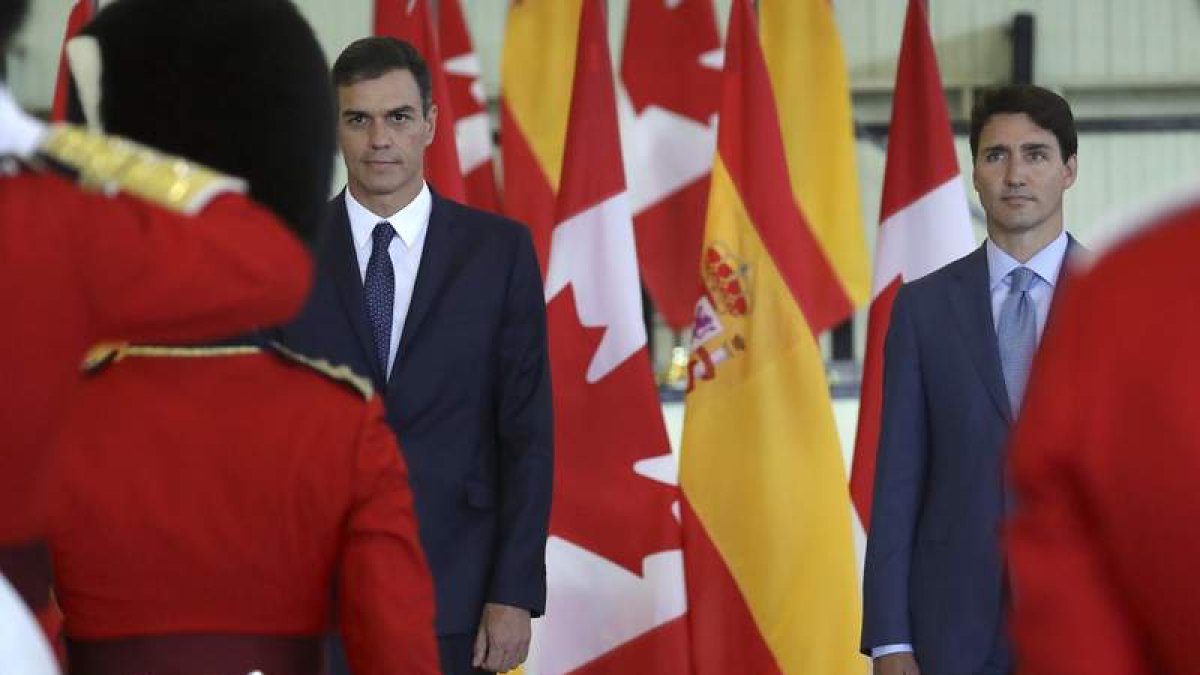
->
[282,192,553,635]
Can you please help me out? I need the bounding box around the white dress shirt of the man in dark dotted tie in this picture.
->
[346,184,433,380]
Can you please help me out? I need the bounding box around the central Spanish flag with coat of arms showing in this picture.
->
[680,0,866,675]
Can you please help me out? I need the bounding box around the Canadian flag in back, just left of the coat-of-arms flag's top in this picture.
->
[618,0,721,330]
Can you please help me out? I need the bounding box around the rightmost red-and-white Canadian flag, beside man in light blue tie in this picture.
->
[850,0,974,526]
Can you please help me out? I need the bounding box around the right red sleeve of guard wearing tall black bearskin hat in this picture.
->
[338,398,439,675]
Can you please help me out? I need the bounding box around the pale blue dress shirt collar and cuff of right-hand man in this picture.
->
[871,229,1067,658]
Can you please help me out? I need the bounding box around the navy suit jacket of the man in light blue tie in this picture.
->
[862,239,1079,675]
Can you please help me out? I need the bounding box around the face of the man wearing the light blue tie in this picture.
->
[974,113,1075,240]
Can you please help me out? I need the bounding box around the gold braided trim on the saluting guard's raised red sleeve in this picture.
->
[40,124,246,214]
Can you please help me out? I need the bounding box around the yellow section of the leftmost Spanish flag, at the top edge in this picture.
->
[500,0,583,195]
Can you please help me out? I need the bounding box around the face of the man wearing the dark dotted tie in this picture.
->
[337,70,437,207]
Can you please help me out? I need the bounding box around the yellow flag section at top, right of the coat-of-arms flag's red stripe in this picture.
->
[758,0,871,306]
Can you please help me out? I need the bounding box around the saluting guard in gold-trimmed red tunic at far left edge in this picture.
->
[0,1,316,658]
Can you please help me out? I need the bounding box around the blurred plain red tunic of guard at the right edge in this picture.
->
[1009,196,1200,675]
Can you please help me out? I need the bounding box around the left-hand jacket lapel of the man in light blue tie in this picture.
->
[949,241,1013,422]
